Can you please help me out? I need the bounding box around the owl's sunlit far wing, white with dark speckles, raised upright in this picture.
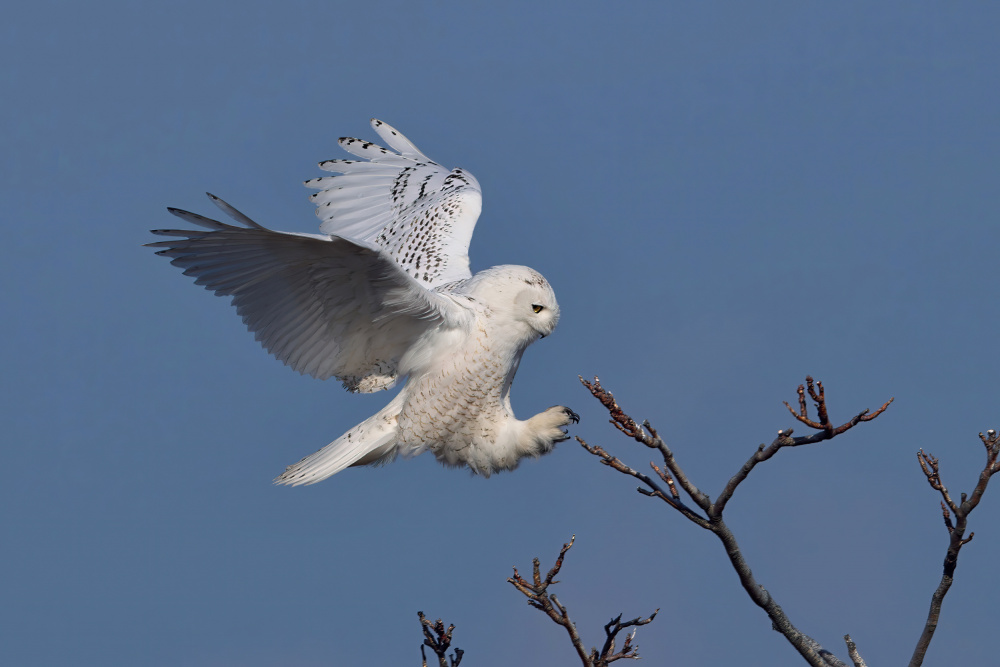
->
[305,119,483,287]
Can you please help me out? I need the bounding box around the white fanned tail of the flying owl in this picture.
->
[274,392,404,486]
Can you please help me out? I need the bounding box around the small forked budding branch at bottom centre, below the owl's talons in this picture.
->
[507,535,660,667]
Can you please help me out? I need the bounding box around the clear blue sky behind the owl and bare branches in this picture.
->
[0,2,1000,667]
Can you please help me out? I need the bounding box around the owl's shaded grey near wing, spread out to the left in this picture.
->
[149,195,468,392]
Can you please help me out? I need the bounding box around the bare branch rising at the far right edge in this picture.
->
[910,429,1000,667]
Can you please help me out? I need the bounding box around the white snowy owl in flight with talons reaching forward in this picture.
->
[149,120,579,486]
